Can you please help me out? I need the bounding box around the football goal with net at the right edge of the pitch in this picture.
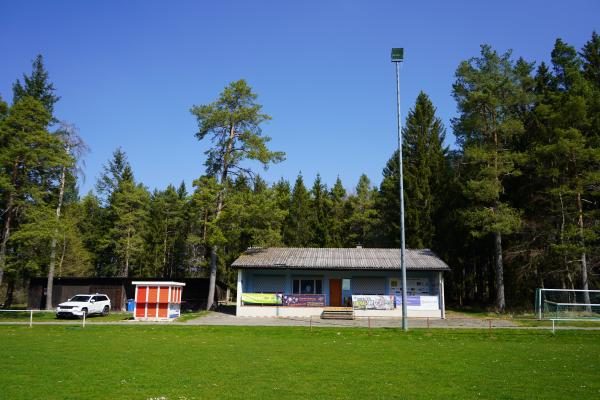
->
[535,289,600,319]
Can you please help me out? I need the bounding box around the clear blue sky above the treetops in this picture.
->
[0,0,600,194]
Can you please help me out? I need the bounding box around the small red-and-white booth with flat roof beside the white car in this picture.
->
[131,281,185,321]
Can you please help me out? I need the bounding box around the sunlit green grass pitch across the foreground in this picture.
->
[0,325,600,400]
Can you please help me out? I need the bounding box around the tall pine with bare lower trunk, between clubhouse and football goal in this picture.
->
[453,45,529,312]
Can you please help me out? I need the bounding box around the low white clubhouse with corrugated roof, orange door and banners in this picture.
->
[232,247,450,318]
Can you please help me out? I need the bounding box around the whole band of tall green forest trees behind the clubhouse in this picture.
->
[0,32,600,312]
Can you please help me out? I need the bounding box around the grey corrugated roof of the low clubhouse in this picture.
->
[232,247,450,271]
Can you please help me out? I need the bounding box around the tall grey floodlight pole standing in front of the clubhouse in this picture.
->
[392,48,408,331]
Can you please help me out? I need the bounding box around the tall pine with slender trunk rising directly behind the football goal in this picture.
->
[537,39,600,303]
